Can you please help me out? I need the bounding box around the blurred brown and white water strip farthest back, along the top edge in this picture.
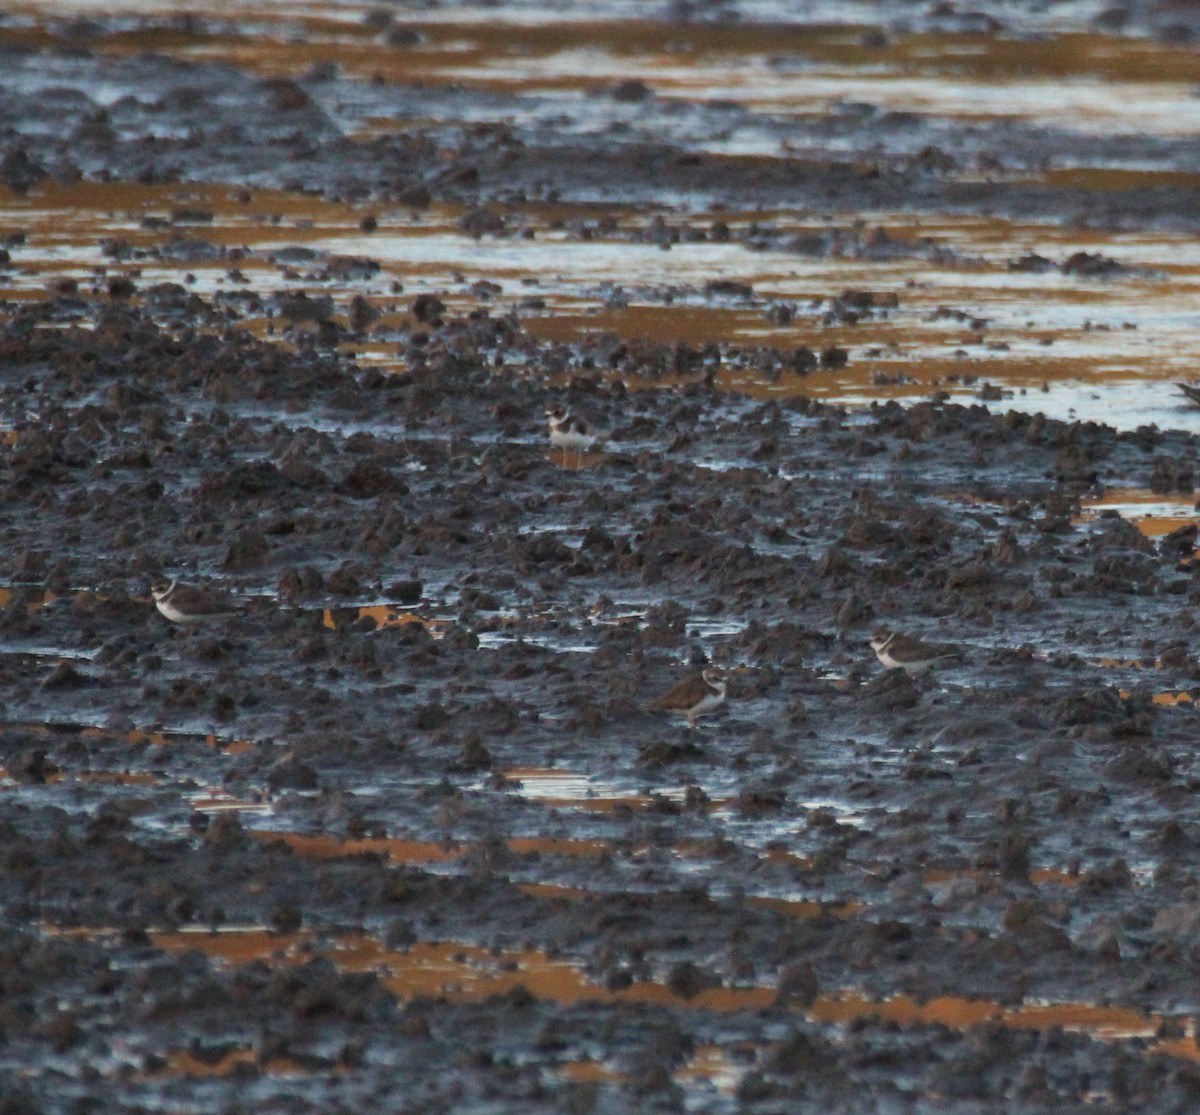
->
[13,9,1194,142]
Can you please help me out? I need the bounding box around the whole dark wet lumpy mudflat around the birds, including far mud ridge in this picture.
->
[7,2,1200,1113]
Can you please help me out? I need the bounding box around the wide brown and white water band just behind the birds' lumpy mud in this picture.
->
[7,181,1200,429]
